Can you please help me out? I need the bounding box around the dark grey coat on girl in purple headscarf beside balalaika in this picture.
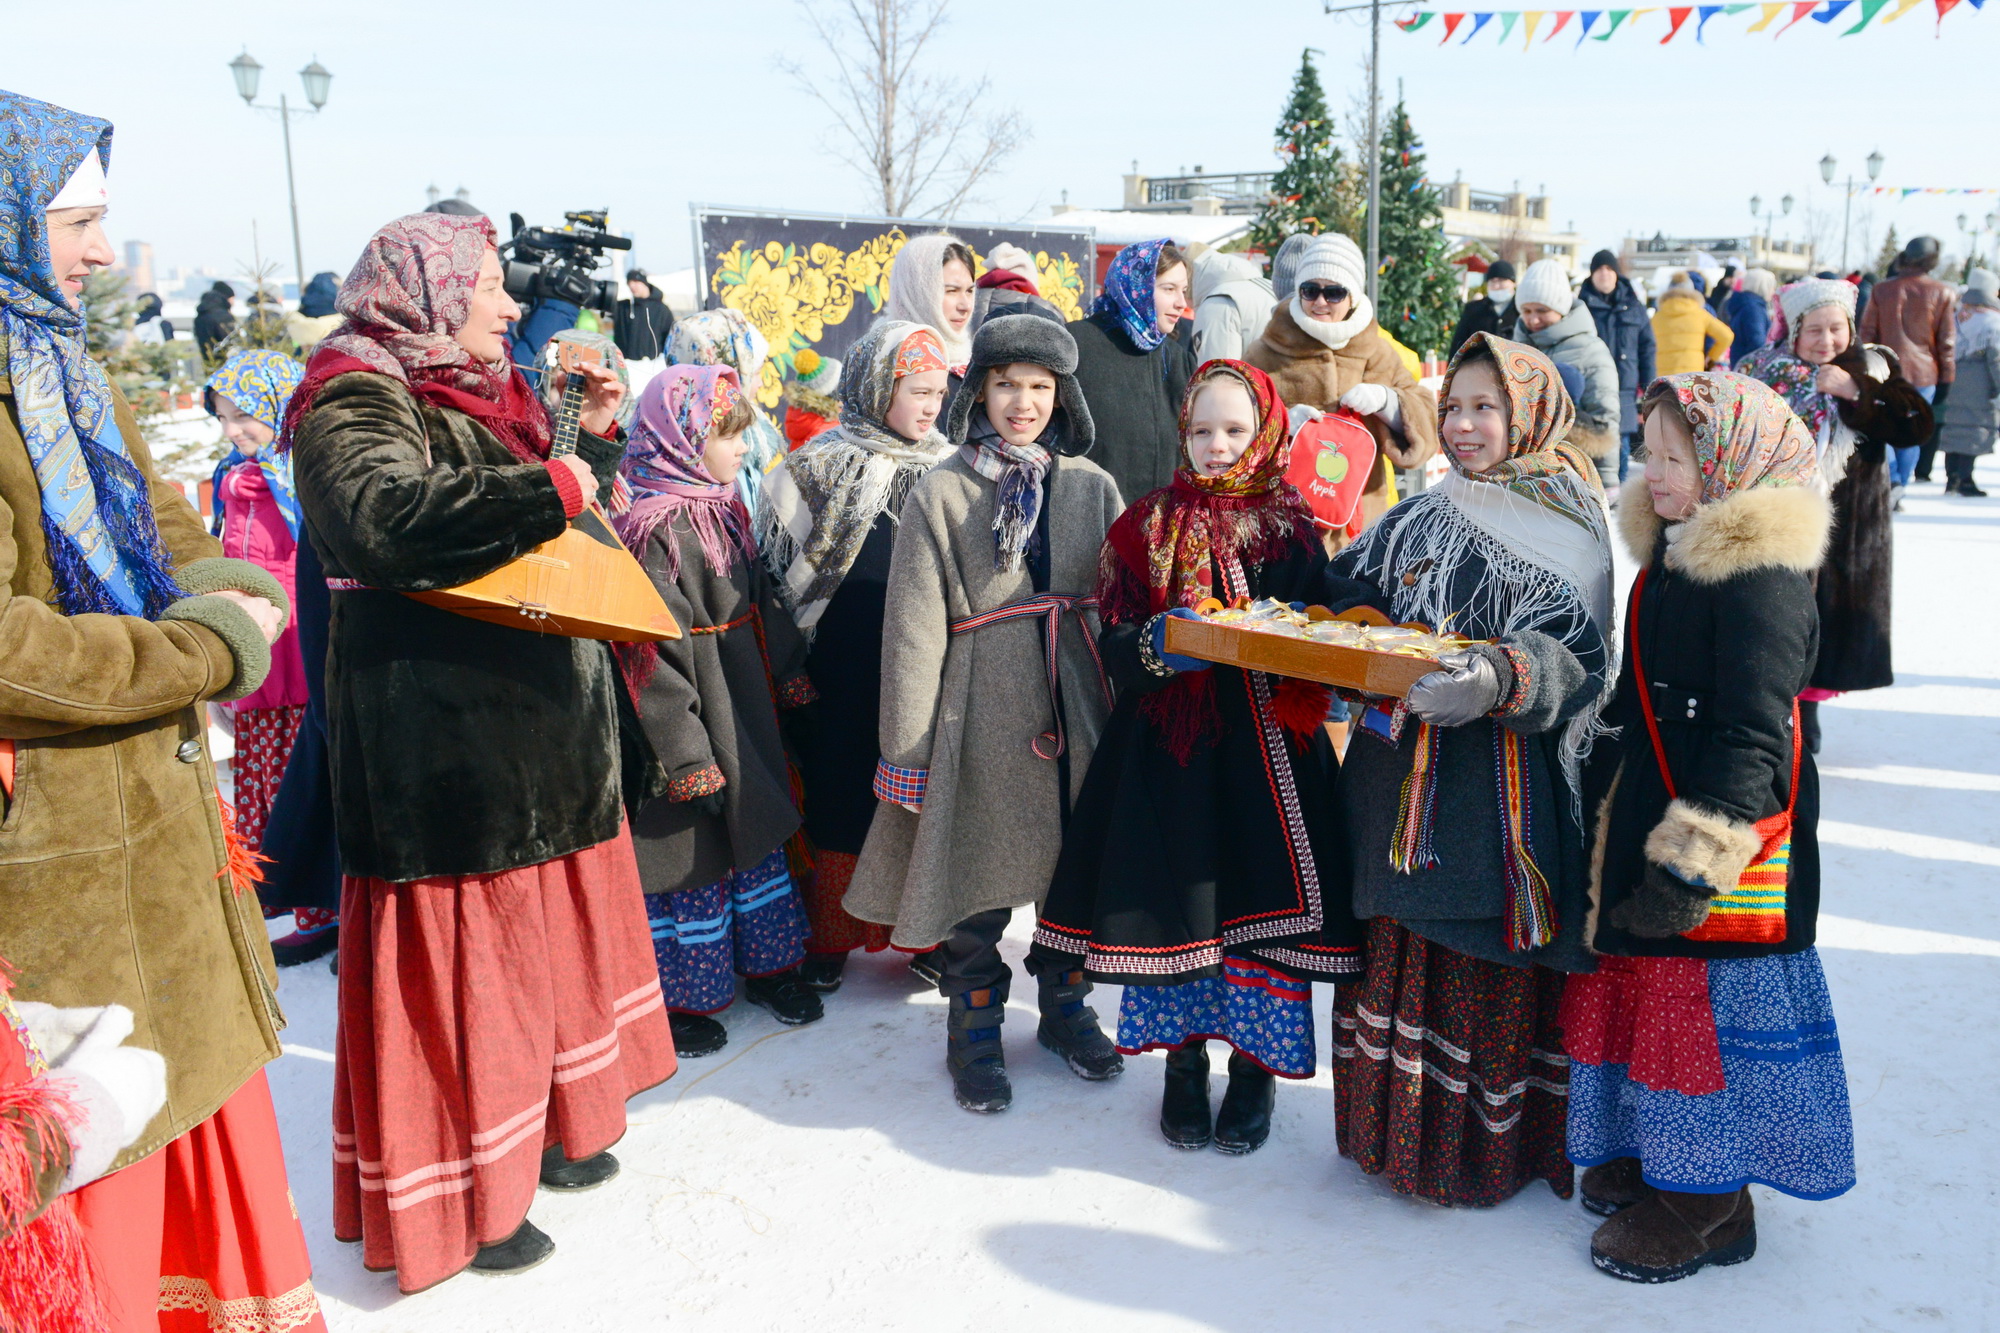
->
[626,516,812,893]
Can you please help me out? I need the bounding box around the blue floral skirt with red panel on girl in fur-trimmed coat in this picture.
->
[1562,949,1854,1199]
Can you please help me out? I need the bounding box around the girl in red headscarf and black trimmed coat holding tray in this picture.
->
[1034,360,1370,1153]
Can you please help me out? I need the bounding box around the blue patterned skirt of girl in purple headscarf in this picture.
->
[646,847,806,1013]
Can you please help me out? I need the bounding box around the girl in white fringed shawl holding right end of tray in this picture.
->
[1334,332,1616,1205]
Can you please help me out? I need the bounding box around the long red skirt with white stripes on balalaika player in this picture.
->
[334,827,674,1291]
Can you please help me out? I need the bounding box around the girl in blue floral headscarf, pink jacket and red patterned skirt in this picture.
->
[202,348,324,852]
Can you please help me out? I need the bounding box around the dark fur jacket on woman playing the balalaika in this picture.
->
[292,372,648,883]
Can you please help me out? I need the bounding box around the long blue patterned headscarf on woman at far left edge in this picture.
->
[0,92,182,618]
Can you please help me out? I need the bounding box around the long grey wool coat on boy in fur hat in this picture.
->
[844,456,1124,949]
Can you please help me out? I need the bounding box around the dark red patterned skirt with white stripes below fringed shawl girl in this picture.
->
[1334,917,1574,1207]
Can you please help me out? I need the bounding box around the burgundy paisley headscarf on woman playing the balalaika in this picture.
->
[286,212,550,462]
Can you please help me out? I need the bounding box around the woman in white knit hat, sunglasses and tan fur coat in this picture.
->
[1244,232,1438,540]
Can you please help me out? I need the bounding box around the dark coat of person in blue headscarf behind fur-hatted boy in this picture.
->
[1066,314,1194,506]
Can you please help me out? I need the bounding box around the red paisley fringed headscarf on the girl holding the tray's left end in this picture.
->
[1098,360,1326,763]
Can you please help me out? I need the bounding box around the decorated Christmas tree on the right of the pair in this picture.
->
[1376,102,1458,356]
